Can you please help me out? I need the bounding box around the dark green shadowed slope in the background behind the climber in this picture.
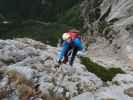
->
[0,0,83,45]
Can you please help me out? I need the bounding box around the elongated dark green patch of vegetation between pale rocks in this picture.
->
[81,57,124,81]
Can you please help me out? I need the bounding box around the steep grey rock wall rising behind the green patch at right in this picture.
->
[81,0,133,70]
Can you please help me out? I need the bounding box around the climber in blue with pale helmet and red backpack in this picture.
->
[58,29,83,66]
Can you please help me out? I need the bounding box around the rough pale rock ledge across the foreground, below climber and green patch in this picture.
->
[0,38,133,100]
